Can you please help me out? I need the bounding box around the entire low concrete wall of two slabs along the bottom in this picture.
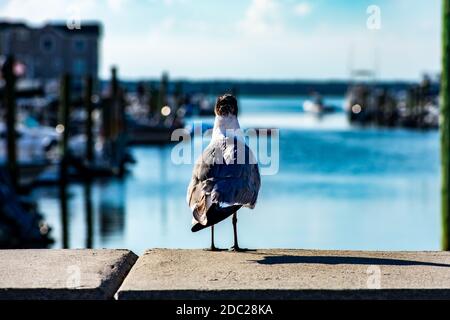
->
[0,249,450,299]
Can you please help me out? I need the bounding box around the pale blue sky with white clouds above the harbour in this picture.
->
[0,0,441,79]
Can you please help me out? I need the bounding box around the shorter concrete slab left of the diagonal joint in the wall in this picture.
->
[0,249,137,300]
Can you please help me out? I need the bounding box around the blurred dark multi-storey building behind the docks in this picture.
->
[0,21,101,82]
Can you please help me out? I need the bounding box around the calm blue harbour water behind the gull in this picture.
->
[32,98,440,254]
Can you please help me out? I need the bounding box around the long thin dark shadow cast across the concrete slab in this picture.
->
[254,255,450,267]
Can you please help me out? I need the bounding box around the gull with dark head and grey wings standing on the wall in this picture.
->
[187,94,261,251]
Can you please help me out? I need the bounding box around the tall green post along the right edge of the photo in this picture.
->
[440,0,450,251]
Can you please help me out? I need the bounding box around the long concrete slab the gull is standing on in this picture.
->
[116,249,450,300]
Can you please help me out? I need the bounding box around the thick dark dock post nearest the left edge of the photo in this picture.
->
[2,55,19,190]
